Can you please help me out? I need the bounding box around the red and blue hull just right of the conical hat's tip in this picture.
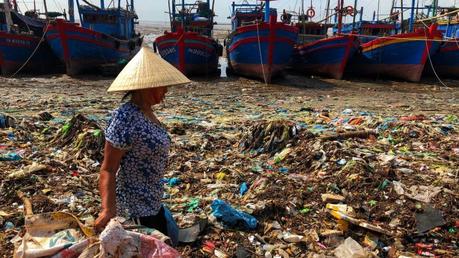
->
[155,30,222,76]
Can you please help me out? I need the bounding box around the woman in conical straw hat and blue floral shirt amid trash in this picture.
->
[95,47,189,235]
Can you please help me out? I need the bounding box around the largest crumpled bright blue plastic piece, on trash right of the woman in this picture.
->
[211,199,258,229]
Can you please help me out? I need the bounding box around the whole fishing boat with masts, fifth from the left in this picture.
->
[292,1,359,80]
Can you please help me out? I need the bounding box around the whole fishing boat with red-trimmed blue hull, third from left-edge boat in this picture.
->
[226,0,298,83]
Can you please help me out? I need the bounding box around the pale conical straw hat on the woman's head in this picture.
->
[107,47,190,92]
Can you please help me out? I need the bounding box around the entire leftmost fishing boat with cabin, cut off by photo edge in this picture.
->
[0,1,59,75]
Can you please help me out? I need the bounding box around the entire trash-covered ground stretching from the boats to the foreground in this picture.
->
[0,75,459,257]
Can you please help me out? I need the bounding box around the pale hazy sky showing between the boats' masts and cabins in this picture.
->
[24,0,459,23]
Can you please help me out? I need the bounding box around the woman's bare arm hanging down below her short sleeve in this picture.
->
[94,141,125,231]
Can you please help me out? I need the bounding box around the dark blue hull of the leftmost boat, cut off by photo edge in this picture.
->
[0,31,59,75]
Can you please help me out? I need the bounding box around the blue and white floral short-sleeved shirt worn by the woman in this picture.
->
[105,102,170,218]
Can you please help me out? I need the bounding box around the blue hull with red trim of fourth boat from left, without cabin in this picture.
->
[226,21,298,82]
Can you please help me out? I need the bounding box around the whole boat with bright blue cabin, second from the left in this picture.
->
[46,0,143,75]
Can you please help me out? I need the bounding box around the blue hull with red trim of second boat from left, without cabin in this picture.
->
[46,19,143,75]
